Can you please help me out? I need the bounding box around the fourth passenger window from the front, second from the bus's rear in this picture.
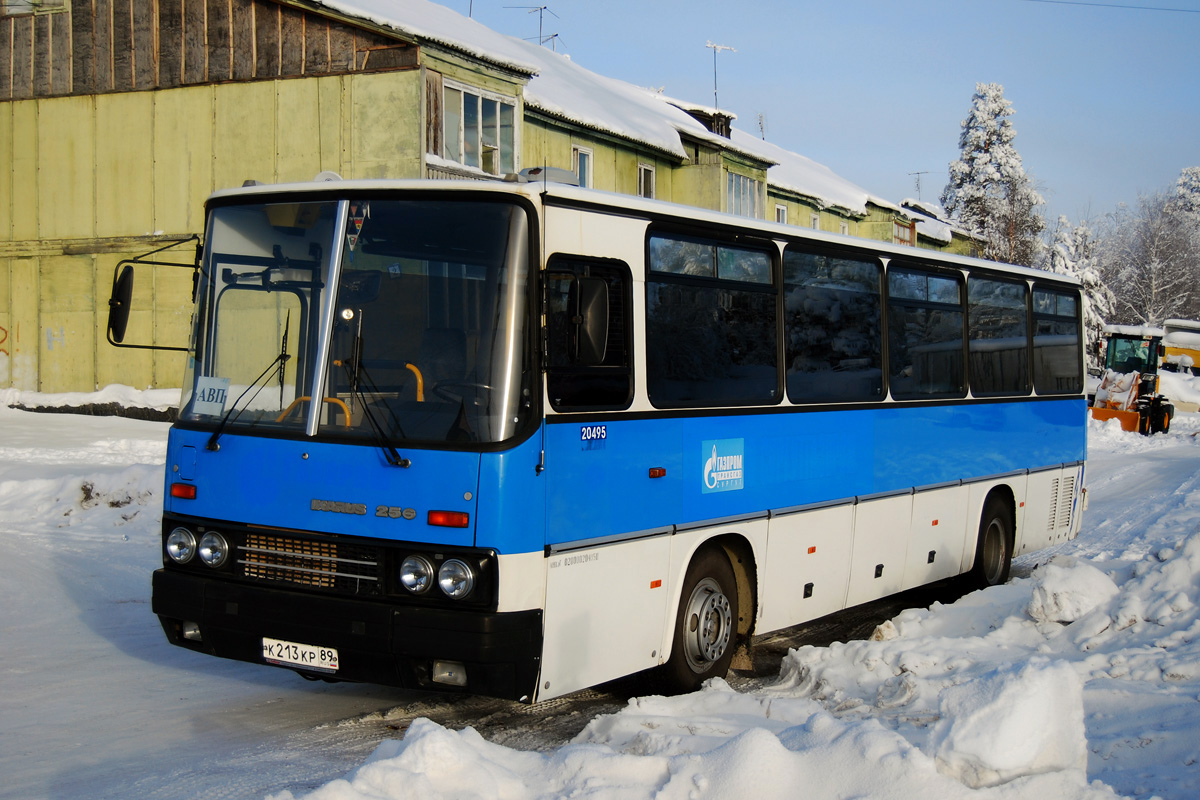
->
[967,276,1030,397]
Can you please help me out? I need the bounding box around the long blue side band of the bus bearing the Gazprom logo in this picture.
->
[540,398,1087,549]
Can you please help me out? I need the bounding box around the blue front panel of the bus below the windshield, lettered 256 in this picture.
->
[166,428,482,548]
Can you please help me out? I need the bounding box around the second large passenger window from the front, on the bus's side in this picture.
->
[784,246,883,403]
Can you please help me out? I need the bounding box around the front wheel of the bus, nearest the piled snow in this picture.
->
[660,547,738,693]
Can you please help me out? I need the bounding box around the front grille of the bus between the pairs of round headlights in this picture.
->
[238,534,383,595]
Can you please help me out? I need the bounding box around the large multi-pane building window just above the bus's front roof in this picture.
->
[439,80,517,175]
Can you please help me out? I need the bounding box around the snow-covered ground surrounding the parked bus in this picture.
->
[0,392,1200,800]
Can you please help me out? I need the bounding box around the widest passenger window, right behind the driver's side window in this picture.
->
[646,234,780,408]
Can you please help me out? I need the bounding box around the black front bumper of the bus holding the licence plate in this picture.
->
[151,570,542,703]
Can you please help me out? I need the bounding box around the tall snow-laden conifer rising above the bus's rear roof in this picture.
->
[942,83,1045,265]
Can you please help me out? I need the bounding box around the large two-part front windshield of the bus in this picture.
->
[180,198,533,446]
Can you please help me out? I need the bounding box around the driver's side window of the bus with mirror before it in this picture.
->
[545,255,634,411]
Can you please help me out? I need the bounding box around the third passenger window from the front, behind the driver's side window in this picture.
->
[888,267,966,399]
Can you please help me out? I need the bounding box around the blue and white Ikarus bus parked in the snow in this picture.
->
[121,181,1087,702]
